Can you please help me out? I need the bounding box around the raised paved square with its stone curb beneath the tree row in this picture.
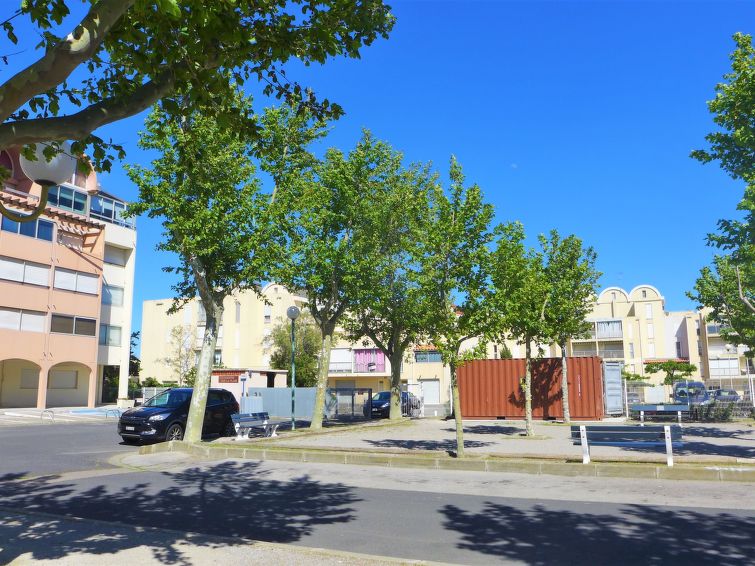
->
[140,419,755,482]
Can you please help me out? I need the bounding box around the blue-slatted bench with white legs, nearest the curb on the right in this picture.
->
[571,425,684,466]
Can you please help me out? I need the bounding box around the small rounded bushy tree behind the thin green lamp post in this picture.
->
[270,311,321,387]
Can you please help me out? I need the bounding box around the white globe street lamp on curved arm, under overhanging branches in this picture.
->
[5,142,77,222]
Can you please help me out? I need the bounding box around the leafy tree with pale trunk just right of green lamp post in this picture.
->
[268,121,384,429]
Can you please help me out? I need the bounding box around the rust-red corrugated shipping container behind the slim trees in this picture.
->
[457,357,604,420]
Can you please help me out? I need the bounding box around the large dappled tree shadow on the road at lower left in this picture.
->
[0,462,359,564]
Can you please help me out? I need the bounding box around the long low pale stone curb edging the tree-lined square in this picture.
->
[139,441,755,482]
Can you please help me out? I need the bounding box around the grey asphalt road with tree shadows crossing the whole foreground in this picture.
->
[0,424,755,566]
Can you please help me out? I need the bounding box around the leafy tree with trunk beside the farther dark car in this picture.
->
[344,144,435,419]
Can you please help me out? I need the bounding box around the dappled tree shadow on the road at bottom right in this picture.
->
[441,502,755,565]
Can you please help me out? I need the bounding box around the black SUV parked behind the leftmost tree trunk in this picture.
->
[118,387,239,444]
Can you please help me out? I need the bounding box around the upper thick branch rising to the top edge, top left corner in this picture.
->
[0,0,136,123]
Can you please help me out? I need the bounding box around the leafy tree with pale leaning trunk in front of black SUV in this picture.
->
[128,94,280,442]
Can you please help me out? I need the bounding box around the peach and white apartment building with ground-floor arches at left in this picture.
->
[0,150,136,408]
